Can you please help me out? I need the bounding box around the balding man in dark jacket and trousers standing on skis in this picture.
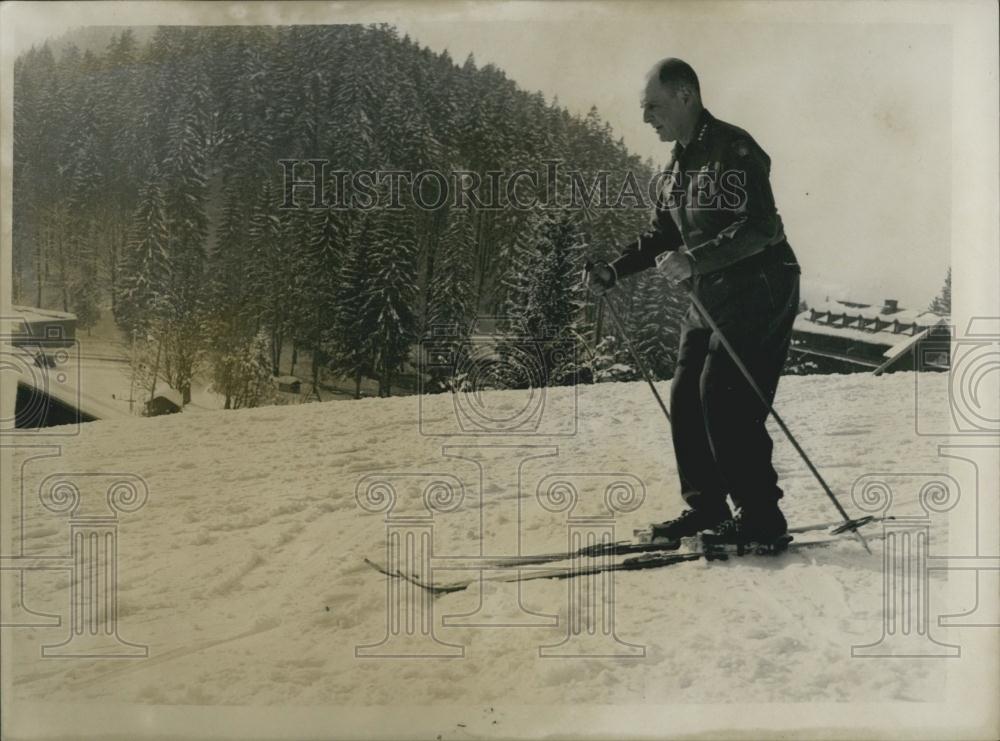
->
[586,58,800,544]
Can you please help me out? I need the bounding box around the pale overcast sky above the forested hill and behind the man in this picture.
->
[7,2,961,308]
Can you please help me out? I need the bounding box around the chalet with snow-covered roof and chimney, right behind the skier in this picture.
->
[790,299,951,375]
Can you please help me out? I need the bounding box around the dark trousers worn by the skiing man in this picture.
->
[670,261,799,508]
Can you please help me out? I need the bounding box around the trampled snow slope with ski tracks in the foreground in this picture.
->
[12,374,947,707]
